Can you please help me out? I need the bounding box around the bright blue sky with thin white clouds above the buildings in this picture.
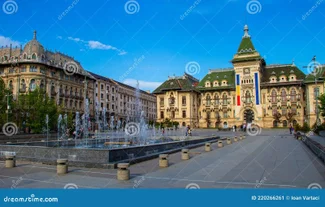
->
[0,0,325,90]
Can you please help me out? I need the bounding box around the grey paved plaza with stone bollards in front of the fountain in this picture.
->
[0,129,325,188]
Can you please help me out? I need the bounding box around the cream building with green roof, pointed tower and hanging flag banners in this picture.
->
[153,25,324,128]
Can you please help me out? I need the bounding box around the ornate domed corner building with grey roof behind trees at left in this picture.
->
[0,31,95,115]
